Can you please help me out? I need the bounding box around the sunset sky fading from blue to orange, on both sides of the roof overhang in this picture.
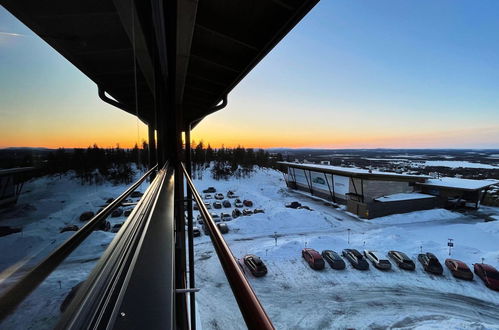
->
[0,0,499,148]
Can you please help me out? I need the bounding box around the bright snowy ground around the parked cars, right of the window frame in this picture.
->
[191,170,499,329]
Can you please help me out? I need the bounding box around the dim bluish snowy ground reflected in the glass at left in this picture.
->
[0,173,148,329]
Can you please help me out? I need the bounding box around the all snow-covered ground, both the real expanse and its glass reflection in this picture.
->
[0,170,499,329]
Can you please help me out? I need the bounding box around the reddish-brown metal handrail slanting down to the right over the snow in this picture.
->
[181,164,274,329]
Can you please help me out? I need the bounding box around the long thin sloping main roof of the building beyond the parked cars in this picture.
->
[279,162,430,182]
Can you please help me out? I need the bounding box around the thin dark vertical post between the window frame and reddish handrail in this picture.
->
[185,124,196,330]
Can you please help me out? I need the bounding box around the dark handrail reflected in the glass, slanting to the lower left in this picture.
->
[0,166,157,321]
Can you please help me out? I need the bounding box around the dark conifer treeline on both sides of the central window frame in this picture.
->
[1,141,283,184]
